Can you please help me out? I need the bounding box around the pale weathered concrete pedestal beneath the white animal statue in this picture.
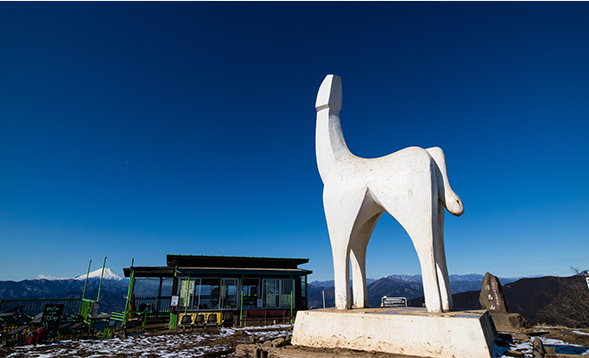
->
[292,308,497,358]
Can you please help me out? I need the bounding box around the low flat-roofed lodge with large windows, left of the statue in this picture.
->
[123,255,312,328]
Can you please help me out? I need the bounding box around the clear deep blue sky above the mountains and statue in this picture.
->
[0,1,589,280]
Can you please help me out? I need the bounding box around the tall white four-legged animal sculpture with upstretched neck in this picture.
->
[315,75,464,312]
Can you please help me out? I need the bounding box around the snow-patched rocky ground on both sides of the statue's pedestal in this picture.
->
[0,325,589,358]
